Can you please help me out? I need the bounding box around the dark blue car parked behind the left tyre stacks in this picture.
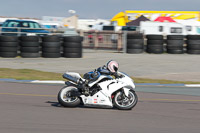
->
[1,20,50,36]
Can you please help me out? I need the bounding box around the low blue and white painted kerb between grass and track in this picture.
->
[0,79,200,87]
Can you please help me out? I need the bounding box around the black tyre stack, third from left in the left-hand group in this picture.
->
[42,36,61,58]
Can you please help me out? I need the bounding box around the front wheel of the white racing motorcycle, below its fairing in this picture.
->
[113,90,138,110]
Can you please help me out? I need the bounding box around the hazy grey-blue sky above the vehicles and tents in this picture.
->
[0,0,200,19]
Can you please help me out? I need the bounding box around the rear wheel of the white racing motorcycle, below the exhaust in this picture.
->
[58,86,80,107]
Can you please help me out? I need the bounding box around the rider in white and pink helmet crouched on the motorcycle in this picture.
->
[79,60,120,96]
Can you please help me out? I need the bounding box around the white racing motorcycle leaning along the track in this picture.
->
[58,67,138,110]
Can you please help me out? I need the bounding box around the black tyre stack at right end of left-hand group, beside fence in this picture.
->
[63,36,83,58]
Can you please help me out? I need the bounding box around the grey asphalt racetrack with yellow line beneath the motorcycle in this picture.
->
[0,82,200,133]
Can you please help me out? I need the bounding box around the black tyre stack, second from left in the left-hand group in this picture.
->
[20,36,40,58]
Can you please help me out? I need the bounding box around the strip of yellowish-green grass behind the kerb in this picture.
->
[0,68,200,84]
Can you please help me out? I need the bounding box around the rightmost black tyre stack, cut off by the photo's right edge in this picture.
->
[186,35,200,54]
